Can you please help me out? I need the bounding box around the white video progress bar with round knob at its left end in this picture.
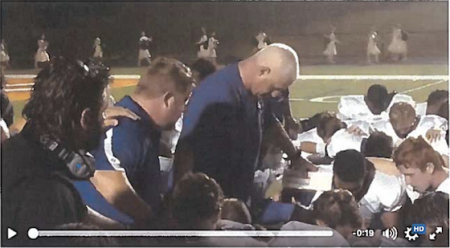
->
[28,228,333,239]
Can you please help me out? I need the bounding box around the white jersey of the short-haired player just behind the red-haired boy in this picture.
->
[371,115,449,156]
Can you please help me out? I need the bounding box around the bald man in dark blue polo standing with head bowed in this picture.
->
[174,44,314,202]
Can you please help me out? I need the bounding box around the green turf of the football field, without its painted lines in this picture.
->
[8,64,448,125]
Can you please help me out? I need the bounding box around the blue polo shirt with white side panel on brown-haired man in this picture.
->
[77,96,161,223]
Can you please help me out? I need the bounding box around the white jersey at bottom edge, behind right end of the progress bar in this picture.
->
[269,221,349,247]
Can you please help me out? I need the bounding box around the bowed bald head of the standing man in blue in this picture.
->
[240,43,300,95]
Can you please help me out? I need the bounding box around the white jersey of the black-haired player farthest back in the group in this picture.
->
[337,94,416,123]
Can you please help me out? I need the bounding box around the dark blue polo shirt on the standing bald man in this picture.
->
[180,64,274,201]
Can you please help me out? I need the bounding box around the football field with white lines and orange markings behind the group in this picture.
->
[6,64,449,130]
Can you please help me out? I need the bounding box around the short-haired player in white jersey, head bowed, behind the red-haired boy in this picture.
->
[372,102,449,161]
